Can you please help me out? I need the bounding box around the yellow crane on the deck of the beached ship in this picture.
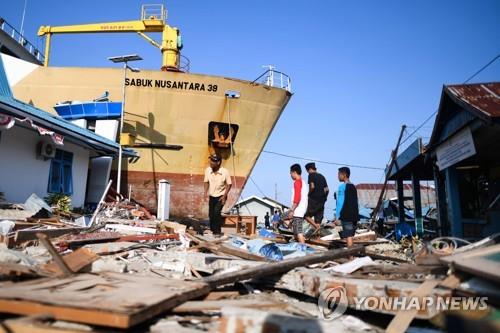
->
[38,5,182,71]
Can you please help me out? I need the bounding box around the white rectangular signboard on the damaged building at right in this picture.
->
[436,127,476,170]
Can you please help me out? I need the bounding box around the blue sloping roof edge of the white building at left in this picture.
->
[0,53,138,157]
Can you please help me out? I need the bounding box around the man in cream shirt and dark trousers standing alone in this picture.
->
[204,154,232,237]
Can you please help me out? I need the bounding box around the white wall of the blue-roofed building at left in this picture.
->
[0,125,89,207]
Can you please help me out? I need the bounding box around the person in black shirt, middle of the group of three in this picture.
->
[304,163,329,229]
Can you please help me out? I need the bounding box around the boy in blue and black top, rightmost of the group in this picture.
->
[335,167,359,247]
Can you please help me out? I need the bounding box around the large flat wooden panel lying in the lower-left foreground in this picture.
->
[0,272,210,328]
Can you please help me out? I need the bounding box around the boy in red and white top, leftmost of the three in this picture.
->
[288,164,308,243]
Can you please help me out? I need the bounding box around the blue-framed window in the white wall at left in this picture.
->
[47,149,73,195]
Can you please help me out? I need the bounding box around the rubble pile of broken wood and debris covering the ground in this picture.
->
[0,196,500,333]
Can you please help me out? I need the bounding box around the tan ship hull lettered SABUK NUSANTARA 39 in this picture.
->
[6,54,291,218]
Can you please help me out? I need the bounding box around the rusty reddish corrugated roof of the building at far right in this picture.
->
[446,82,500,118]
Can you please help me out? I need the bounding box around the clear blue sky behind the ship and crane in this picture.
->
[0,0,500,218]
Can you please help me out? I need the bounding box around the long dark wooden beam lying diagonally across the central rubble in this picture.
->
[203,246,364,288]
